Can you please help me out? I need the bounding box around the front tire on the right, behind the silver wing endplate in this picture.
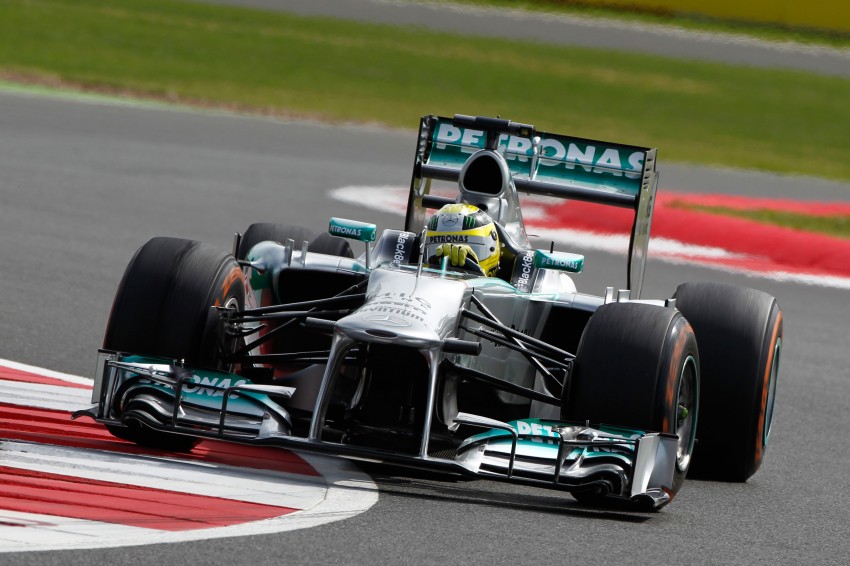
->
[561,303,701,502]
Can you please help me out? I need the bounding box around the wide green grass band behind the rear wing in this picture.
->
[0,0,850,180]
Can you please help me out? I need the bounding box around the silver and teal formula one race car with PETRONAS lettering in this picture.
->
[75,115,782,510]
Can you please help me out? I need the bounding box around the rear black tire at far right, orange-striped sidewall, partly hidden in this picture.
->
[674,283,782,482]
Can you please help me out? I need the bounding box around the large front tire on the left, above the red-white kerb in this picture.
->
[103,237,245,450]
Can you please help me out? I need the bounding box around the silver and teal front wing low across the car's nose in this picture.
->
[73,351,677,510]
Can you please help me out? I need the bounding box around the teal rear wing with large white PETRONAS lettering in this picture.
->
[405,115,658,298]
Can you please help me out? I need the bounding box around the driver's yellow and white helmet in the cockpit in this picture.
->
[426,203,499,277]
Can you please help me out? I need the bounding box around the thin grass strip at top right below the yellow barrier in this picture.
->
[424,0,850,48]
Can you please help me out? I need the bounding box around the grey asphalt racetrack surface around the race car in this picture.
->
[0,90,850,566]
